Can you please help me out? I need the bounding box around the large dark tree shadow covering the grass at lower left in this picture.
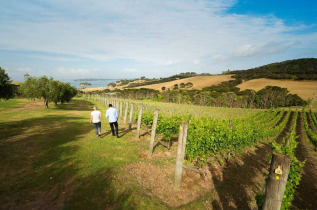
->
[0,101,133,209]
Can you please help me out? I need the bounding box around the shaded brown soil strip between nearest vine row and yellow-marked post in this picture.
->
[210,112,294,209]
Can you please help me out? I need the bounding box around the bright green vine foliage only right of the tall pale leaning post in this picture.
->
[186,111,290,162]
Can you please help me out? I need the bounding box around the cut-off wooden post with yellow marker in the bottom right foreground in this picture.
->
[263,153,291,210]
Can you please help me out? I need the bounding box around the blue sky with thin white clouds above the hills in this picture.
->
[0,0,317,81]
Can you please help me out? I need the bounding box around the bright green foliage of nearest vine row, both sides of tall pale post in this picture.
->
[142,104,290,164]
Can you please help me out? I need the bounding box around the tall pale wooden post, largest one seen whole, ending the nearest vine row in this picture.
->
[174,121,188,189]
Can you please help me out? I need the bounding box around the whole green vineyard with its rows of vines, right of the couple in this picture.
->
[84,95,317,209]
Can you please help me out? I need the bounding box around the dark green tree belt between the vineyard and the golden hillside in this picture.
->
[161,86,308,109]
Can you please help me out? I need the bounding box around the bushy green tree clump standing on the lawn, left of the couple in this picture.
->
[19,75,77,107]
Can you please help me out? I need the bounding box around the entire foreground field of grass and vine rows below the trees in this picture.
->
[0,97,317,209]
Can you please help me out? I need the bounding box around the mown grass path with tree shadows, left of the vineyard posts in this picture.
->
[0,99,180,209]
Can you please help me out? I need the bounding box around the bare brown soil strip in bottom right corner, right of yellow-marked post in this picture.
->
[292,113,317,210]
